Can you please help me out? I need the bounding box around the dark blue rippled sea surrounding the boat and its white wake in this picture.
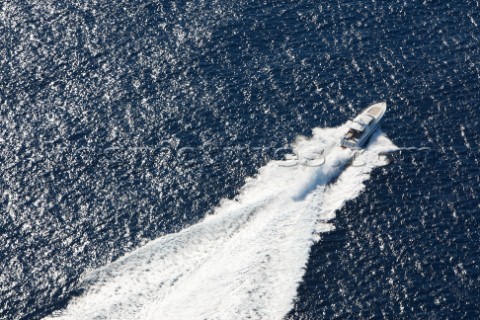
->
[0,0,480,319]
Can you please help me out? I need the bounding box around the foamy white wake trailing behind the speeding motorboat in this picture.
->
[45,127,395,320]
